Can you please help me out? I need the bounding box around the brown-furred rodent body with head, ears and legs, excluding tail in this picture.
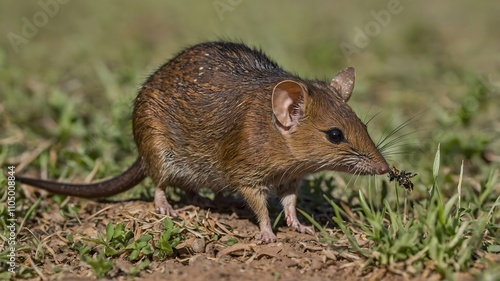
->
[18,42,389,242]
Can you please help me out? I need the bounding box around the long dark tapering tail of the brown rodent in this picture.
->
[16,158,146,198]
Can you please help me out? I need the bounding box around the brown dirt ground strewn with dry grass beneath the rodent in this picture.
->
[18,192,488,281]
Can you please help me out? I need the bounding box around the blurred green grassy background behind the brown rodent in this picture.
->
[0,0,500,278]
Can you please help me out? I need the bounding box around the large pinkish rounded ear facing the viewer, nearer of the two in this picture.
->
[272,80,306,134]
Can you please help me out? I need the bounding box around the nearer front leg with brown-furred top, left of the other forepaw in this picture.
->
[240,186,276,243]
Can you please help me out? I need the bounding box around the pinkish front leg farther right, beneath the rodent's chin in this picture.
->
[278,180,314,235]
